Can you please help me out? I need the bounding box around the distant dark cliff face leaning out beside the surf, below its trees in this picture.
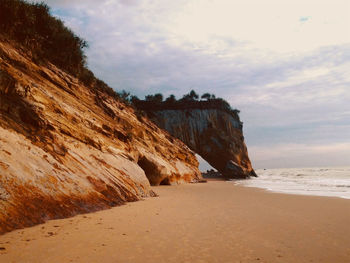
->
[149,108,256,178]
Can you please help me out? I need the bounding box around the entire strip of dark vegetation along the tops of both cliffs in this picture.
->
[0,0,239,118]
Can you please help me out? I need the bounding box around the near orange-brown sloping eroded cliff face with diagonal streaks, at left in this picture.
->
[0,43,201,233]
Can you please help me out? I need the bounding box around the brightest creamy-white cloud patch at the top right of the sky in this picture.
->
[168,0,350,52]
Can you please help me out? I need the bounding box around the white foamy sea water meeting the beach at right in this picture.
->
[235,167,350,199]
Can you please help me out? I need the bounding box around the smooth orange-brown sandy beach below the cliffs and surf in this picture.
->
[0,181,350,263]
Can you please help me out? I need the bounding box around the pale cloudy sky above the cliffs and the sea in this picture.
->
[35,0,350,168]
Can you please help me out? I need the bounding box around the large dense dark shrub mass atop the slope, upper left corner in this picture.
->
[0,0,87,76]
